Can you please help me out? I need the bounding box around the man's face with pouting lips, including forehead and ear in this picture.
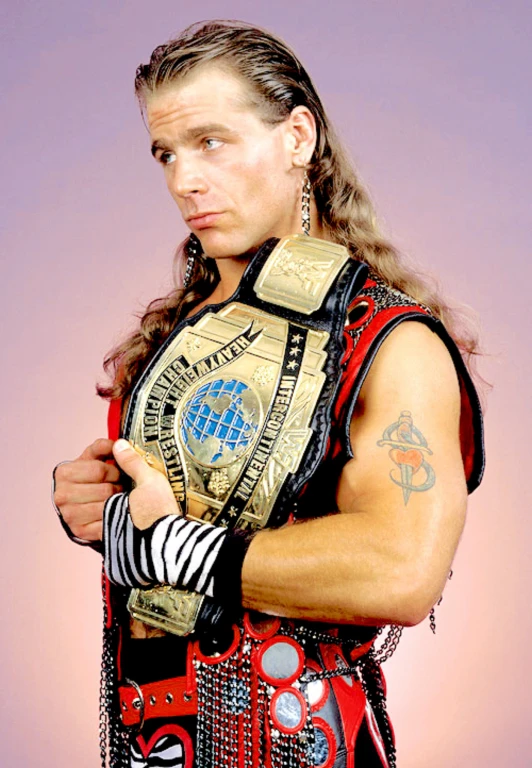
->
[147,66,308,258]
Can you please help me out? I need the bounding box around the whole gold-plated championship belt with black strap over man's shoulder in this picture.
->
[124,235,367,635]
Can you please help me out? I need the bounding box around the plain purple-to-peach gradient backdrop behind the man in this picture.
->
[0,0,532,768]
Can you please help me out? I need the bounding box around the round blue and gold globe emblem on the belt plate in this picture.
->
[180,378,260,467]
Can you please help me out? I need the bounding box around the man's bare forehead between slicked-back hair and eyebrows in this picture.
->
[146,66,256,134]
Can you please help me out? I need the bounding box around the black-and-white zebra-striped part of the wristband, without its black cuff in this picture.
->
[103,493,227,597]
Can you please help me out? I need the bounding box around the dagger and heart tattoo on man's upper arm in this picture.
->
[377,411,436,506]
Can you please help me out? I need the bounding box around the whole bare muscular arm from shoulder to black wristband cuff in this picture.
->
[242,322,467,625]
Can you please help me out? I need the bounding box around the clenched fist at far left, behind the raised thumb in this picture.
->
[54,438,123,541]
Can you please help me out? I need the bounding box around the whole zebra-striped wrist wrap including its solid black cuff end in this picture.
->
[103,493,254,606]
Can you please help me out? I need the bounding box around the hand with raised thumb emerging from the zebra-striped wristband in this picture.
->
[113,440,183,530]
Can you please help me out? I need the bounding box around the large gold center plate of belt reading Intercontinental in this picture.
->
[127,303,329,528]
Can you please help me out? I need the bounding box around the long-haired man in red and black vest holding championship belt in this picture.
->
[54,22,483,768]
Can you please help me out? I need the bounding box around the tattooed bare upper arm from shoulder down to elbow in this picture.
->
[337,322,467,582]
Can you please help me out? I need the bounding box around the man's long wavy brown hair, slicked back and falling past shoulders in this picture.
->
[97,20,484,399]
